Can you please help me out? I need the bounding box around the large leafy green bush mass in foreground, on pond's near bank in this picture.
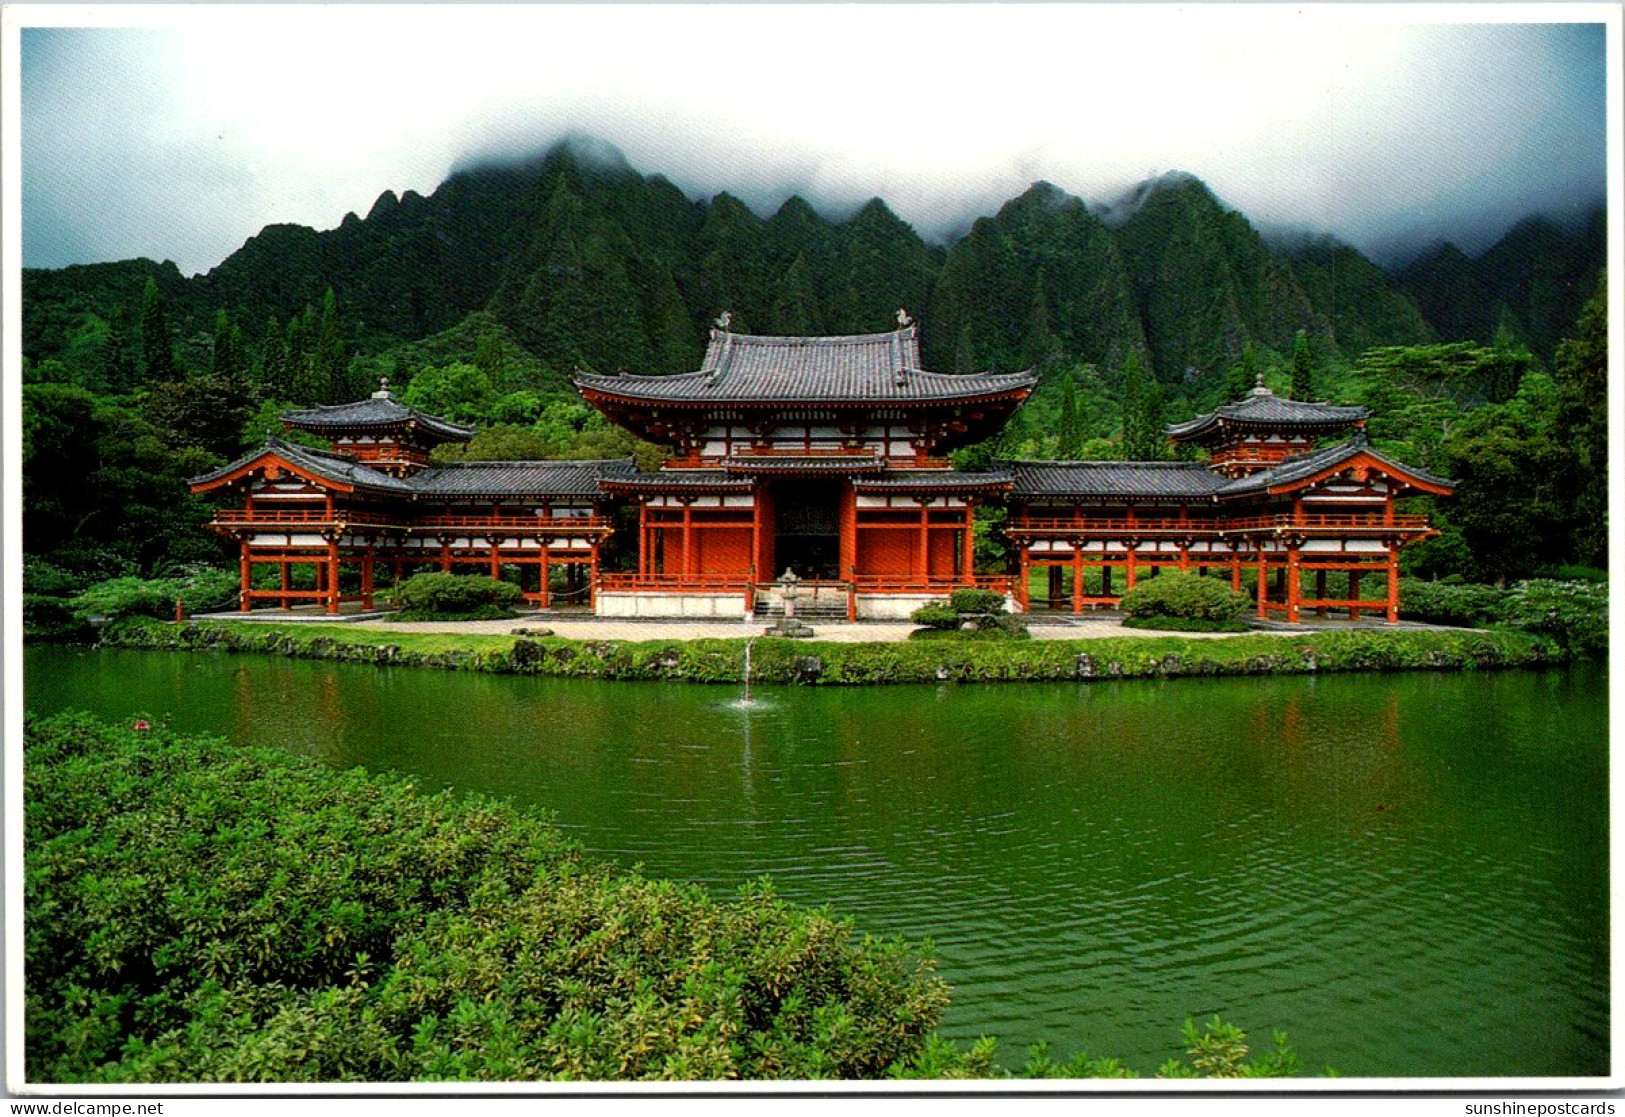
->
[24,715,947,1083]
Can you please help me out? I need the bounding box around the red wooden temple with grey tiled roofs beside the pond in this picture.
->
[192,312,1451,623]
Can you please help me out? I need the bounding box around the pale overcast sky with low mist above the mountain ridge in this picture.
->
[13,5,1607,273]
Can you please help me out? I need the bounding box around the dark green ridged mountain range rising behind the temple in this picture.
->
[24,137,1606,390]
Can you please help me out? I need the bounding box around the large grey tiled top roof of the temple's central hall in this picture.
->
[575,325,1037,403]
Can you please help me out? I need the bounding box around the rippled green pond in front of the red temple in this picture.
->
[24,647,1609,1076]
